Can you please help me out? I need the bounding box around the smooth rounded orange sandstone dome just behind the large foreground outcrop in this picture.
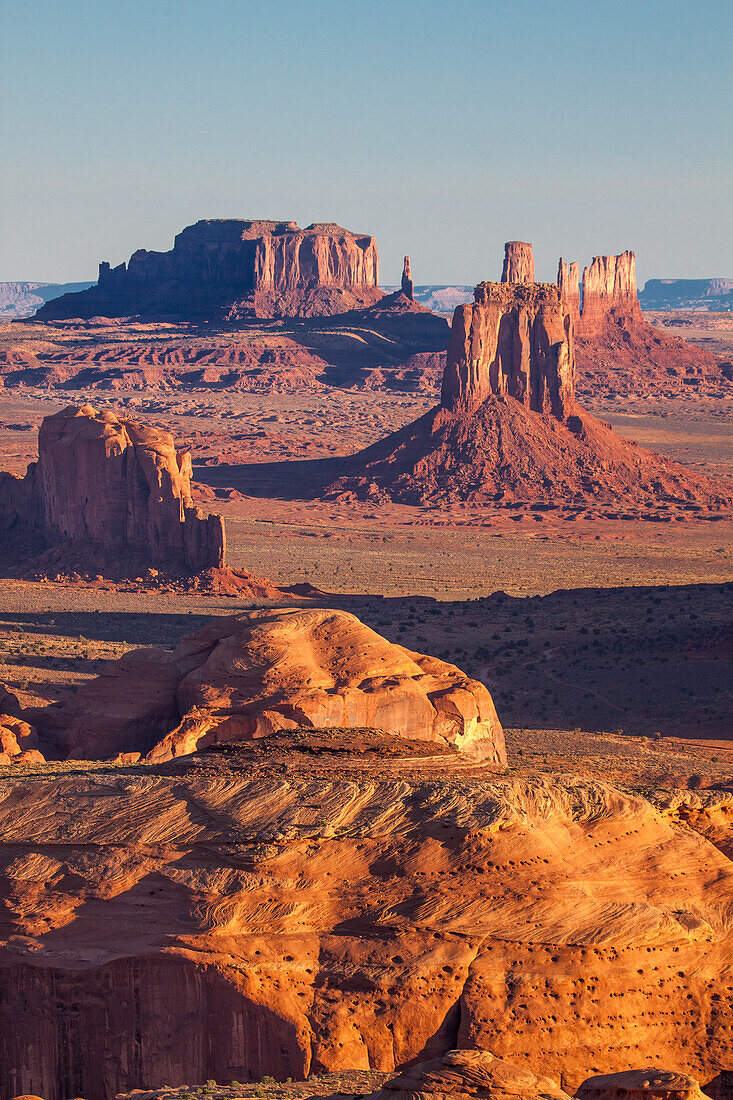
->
[32,608,506,767]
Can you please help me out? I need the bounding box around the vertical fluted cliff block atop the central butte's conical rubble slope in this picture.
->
[441,283,575,420]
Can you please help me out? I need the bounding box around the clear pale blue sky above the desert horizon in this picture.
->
[0,0,733,284]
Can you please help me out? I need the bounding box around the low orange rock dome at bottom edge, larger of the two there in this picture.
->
[375,1051,570,1100]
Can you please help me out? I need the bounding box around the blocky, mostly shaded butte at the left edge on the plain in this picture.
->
[0,405,226,573]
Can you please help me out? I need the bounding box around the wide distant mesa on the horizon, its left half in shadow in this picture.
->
[36,219,381,320]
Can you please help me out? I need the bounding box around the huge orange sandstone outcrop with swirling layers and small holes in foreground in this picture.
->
[0,774,733,1100]
